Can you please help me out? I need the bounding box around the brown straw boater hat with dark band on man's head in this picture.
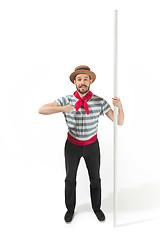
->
[69,65,96,83]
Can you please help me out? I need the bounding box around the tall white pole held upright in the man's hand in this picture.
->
[113,10,118,227]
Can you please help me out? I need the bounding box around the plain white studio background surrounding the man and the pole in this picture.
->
[0,0,160,239]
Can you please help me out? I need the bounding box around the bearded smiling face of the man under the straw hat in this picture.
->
[74,73,92,94]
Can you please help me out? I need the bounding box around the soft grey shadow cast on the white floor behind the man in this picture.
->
[76,182,160,226]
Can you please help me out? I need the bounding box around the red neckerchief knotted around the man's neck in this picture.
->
[73,91,93,115]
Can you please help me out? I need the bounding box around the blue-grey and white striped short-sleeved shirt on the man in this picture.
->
[56,94,111,141]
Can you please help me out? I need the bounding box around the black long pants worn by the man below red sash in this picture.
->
[64,139,101,212]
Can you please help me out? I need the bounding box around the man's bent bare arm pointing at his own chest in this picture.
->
[38,101,74,115]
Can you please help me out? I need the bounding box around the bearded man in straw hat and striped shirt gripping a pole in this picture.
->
[39,65,124,223]
